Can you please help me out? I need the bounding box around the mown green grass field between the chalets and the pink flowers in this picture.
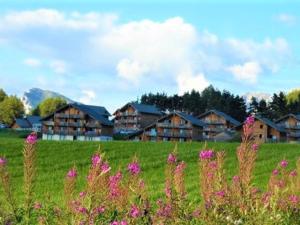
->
[0,135,300,207]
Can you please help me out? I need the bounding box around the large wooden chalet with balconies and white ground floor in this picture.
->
[42,103,113,141]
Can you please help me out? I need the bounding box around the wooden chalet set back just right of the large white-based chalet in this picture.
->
[114,103,162,133]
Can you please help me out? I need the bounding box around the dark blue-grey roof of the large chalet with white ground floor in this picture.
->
[41,103,113,126]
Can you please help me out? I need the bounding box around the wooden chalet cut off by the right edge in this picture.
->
[276,114,300,142]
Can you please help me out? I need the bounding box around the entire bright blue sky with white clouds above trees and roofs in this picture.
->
[0,0,300,112]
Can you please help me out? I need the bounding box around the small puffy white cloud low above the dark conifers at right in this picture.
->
[228,62,262,84]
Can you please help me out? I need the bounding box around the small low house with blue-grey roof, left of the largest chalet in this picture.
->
[11,116,42,132]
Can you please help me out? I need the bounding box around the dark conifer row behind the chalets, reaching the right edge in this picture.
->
[138,85,300,121]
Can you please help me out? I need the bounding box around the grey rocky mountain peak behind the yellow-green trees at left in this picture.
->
[21,88,74,113]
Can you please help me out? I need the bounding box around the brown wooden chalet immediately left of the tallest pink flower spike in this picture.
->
[198,110,241,140]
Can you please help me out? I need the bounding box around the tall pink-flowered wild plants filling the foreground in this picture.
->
[0,117,300,225]
